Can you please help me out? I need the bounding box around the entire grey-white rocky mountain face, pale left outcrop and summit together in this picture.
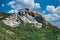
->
[3,8,48,28]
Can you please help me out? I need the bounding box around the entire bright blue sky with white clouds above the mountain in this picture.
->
[0,0,60,28]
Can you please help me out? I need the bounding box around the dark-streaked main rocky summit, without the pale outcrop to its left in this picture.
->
[18,8,48,25]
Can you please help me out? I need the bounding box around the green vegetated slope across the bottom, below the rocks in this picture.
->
[0,22,60,40]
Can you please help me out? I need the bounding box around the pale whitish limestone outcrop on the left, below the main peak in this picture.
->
[2,14,20,27]
